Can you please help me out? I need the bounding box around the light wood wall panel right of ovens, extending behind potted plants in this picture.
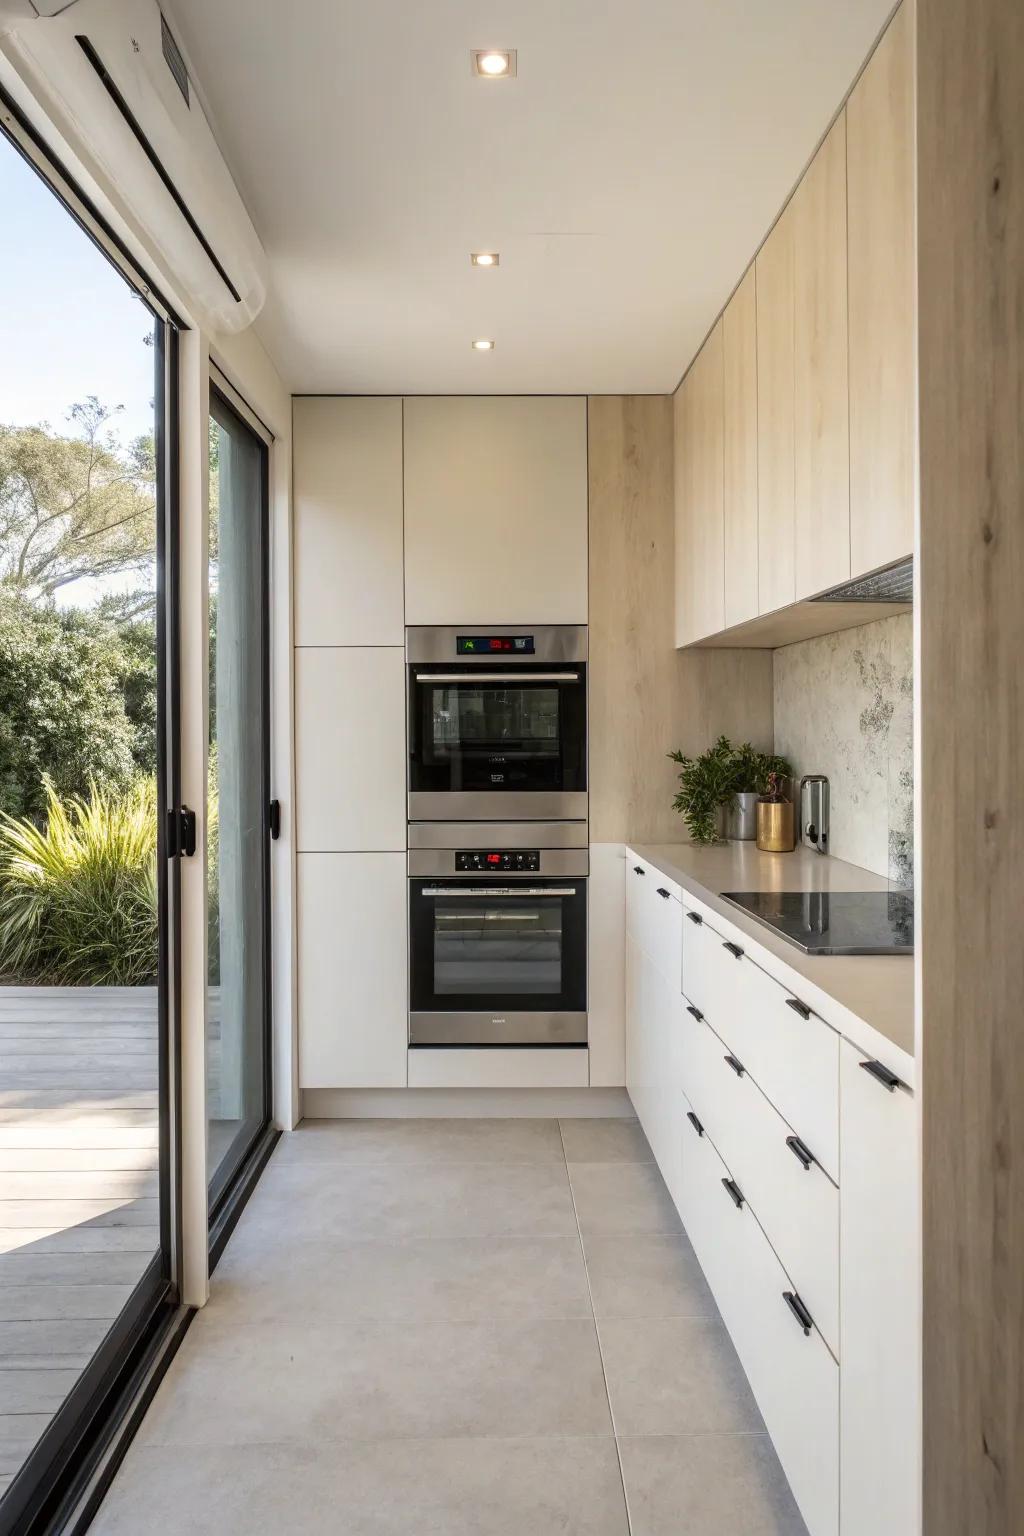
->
[588,395,772,842]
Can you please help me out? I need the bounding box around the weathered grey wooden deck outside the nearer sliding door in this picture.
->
[0,986,160,1491]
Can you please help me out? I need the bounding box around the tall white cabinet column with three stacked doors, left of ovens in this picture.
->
[293,396,408,1087]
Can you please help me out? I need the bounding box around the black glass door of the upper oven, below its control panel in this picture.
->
[408,659,586,820]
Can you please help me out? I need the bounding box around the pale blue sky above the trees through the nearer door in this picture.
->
[0,135,154,439]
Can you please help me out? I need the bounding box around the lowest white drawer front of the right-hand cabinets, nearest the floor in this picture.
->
[682,1103,835,1536]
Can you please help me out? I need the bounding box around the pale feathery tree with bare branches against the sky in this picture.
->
[0,395,155,602]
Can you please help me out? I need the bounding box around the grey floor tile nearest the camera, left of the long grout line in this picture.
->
[91,1439,626,1536]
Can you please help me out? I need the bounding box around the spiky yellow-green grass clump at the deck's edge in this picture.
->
[0,779,158,986]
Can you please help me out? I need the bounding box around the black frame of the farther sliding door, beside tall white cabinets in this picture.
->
[209,371,278,1270]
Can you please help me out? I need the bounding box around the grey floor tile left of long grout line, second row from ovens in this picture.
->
[236,1161,576,1243]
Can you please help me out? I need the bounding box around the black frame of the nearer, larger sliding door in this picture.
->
[0,86,192,1536]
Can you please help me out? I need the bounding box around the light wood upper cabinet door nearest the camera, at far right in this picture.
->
[846,0,917,576]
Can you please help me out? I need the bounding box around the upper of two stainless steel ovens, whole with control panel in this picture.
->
[405,625,586,820]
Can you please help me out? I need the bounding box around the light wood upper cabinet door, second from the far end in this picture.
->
[722,266,757,625]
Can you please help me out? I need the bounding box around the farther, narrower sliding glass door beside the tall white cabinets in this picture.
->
[207,389,270,1213]
